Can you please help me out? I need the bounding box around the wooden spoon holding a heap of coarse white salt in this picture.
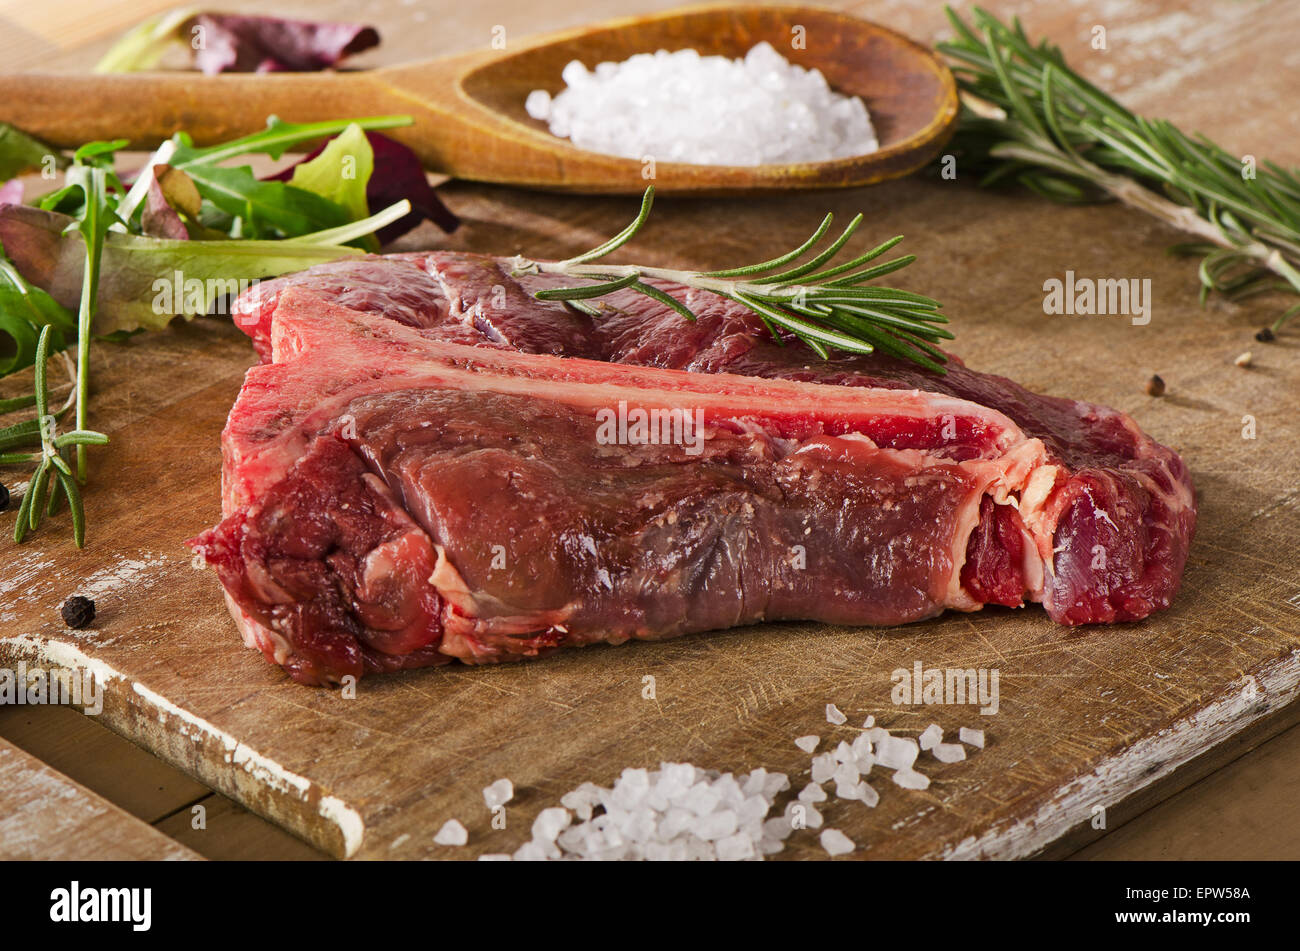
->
[0,5,958,194]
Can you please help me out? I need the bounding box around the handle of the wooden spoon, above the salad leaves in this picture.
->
[0,73,384,148]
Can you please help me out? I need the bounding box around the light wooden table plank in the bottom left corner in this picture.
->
[0,739,203,861]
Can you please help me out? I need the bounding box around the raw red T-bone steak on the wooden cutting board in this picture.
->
[194,252,1196,683]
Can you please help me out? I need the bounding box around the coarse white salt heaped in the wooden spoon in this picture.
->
[524,43,880,165]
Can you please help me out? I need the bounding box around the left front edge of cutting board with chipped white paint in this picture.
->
[0,635,365,859]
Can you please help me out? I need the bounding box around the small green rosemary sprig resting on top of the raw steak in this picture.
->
[515,186,953,373]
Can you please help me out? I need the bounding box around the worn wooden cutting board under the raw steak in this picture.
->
[0,4,1300,857]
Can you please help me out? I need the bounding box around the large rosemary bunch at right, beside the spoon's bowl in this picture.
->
[939,8,1300,330]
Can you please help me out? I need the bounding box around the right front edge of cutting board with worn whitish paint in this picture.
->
[936,651,1300,860]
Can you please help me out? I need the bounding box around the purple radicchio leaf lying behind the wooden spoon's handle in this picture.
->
[182,13,380,75]
